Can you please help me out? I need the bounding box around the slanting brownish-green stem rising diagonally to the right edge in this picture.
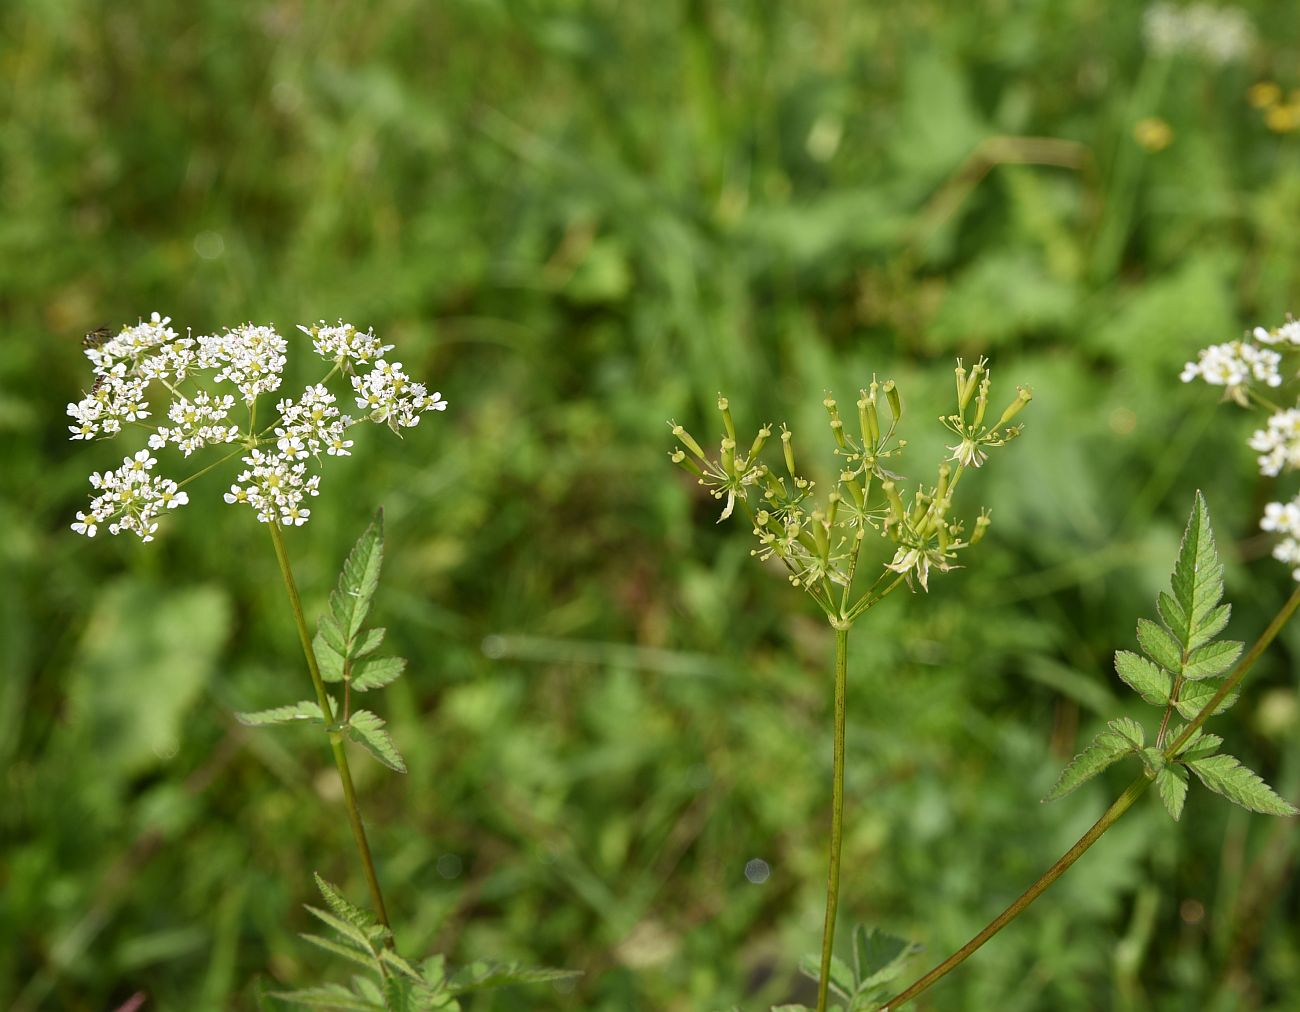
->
[889,588,1300,1009]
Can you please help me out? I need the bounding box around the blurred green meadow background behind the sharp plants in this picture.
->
[0,0,1300,1012]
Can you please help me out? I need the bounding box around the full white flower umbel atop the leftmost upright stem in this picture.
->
[68,313,447,541]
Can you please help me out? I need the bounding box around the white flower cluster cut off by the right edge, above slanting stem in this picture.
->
[1180,317,1300,580]
